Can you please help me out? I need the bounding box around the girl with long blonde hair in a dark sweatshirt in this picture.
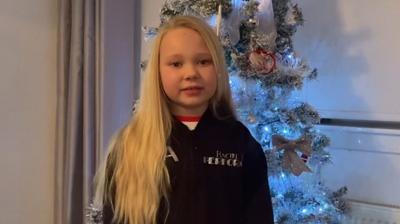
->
[94,16,273,224]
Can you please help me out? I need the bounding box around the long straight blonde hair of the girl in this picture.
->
[94,16,234,224]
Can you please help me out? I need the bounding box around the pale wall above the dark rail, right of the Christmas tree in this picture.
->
[295,0,400,121]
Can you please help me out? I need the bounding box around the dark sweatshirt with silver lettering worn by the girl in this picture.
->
[103,110,273,224]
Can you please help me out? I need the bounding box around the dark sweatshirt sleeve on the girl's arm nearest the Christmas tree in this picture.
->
[243,130,274,224]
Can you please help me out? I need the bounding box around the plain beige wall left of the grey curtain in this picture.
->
[0,0,58,224]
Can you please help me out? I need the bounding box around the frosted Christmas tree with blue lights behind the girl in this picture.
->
[144,0,347,224]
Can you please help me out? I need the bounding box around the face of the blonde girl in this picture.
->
[160,28,217,115]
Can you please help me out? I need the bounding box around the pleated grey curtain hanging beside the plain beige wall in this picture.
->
[54,0,103,224]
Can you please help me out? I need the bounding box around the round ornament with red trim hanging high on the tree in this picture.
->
[248,49,276,74]
